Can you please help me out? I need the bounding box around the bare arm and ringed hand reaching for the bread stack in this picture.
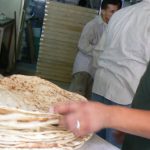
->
[54,102,150,138]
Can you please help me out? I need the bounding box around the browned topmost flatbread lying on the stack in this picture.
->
[0,75,86,112]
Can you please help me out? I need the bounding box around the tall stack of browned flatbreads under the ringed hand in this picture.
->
[0,75,90,150]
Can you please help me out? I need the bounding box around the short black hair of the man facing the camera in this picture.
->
[101,0,122,9]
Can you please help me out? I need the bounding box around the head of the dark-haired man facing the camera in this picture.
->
[101,0,122,23]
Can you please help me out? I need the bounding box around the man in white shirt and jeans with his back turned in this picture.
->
[92,0,150,146]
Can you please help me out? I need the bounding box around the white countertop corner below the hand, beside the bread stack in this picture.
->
[79,135,119,150]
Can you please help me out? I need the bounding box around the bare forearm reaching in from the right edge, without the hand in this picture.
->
[106,106,150,138]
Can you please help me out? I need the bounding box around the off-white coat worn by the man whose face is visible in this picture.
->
[73,16,106,76]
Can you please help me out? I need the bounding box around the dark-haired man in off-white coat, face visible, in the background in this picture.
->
[69,0,122,99]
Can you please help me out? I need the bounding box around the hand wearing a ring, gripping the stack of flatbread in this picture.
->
[54,102,109,136]
